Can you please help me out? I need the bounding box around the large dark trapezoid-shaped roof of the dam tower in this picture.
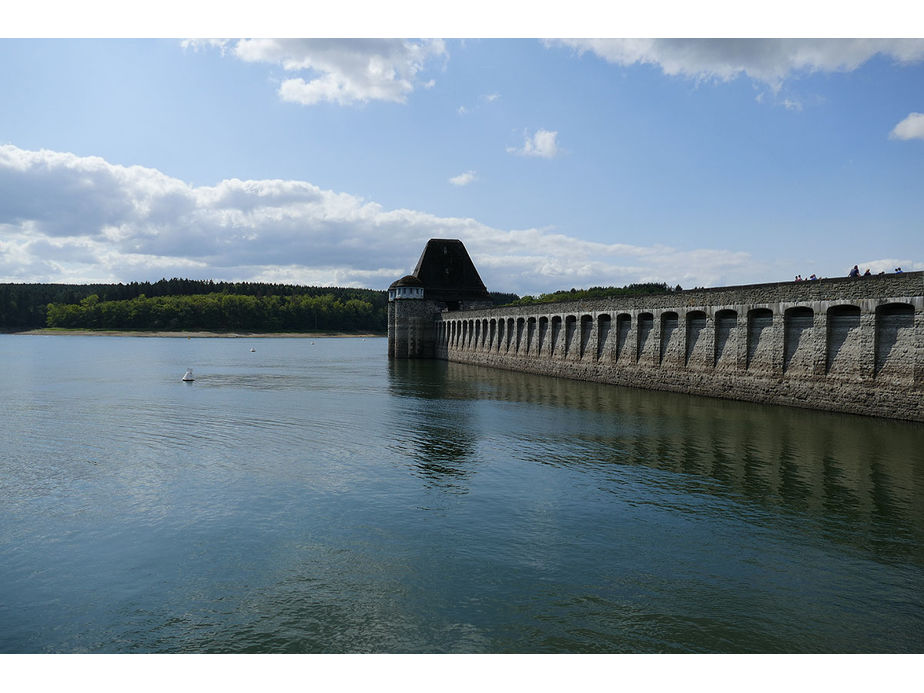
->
[414,238,491,301]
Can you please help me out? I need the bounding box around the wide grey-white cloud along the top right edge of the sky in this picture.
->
[547,38,924,90]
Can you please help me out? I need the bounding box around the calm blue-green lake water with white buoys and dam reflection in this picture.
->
[0,335,924,653]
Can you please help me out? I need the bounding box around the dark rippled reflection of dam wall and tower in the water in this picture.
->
[391,360,924,562]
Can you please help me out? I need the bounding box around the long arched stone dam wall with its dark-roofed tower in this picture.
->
[388,239,924,421]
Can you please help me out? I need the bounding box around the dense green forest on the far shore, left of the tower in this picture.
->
[0,278,518,333]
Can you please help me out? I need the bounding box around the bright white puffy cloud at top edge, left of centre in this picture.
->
[183,39,446,106]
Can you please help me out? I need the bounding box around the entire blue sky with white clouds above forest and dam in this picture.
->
[0,14,924,295]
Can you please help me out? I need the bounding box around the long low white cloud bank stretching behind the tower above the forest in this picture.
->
[0,145,754,293]
